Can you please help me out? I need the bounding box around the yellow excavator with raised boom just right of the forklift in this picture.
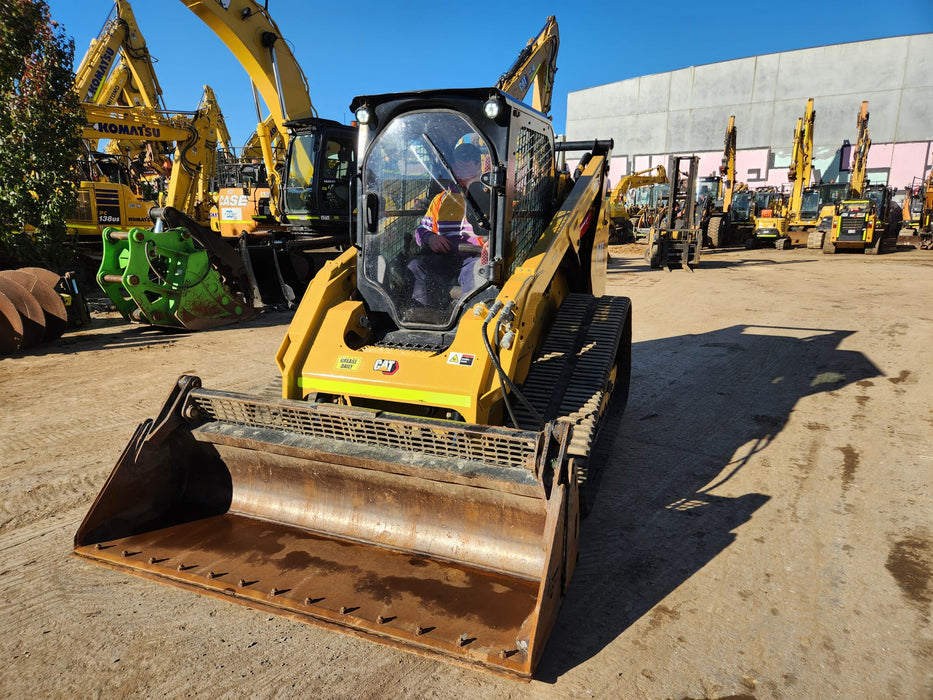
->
[697,115,755,248]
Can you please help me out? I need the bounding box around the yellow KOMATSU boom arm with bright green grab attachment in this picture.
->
[85,95,272,330]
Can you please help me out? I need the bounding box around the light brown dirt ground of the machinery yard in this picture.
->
[0,247,933,699]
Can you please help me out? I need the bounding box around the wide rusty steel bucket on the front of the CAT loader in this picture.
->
[74,376,579,678]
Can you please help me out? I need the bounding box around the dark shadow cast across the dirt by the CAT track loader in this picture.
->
[536,326,880,682]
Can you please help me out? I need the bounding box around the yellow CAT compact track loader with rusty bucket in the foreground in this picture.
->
[74,88,631,678]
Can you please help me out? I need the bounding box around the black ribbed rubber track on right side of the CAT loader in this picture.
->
[514,294,630,460]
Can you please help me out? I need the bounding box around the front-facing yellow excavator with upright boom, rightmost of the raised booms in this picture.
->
[823,102,901,255]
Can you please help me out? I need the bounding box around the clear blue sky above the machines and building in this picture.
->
[47,0,933,146]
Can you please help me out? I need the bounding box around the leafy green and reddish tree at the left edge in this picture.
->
[0,0,84,268]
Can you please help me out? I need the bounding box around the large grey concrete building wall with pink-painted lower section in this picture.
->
[566,34,933,187]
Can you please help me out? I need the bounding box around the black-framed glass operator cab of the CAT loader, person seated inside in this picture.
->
[351,89,556,336]
